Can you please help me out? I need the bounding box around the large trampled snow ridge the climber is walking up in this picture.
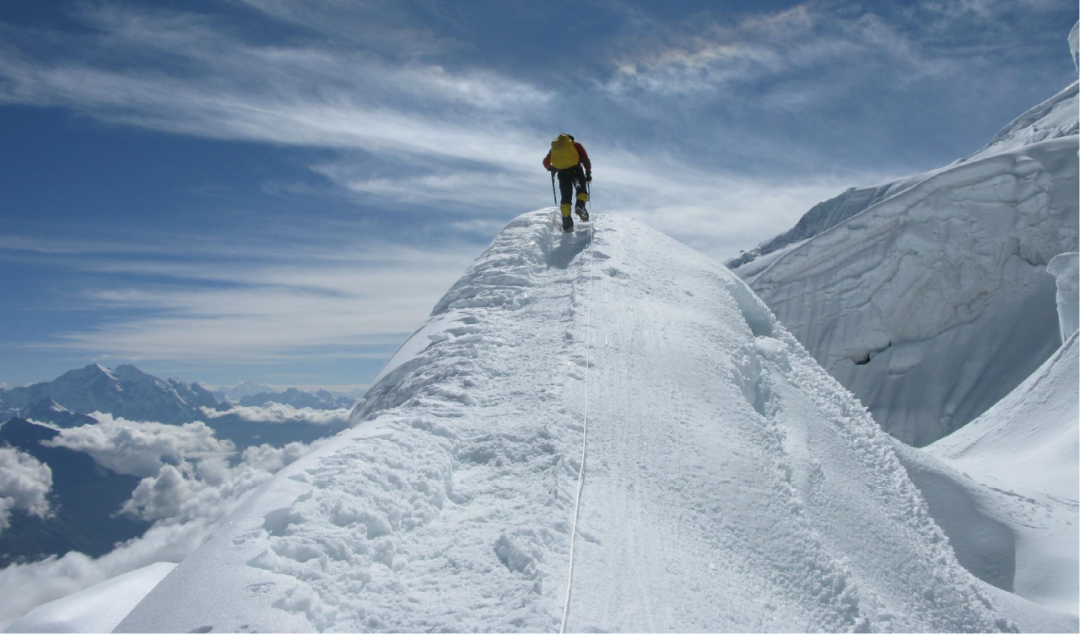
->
[117,211,1080,634]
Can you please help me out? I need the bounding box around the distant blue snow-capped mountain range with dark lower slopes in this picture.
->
[0,364,354,568]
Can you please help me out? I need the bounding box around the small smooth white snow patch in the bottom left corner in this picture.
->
[4,563,176,635]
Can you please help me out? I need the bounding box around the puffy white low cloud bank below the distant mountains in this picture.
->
[0,414,325,632]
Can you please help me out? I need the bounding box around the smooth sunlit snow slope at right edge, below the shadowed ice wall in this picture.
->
[927,336,1080,614]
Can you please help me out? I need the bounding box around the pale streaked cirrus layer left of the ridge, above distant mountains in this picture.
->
[0,232,475,362]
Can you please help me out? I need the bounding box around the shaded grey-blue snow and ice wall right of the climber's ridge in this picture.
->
[748,137,1080,445]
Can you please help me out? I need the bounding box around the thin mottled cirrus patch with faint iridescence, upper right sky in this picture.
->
[603,0,1065,107]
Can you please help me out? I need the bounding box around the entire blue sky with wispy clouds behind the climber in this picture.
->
[0,0,1080,387]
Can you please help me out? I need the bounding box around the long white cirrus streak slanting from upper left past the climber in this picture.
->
[0,2,876,249]
